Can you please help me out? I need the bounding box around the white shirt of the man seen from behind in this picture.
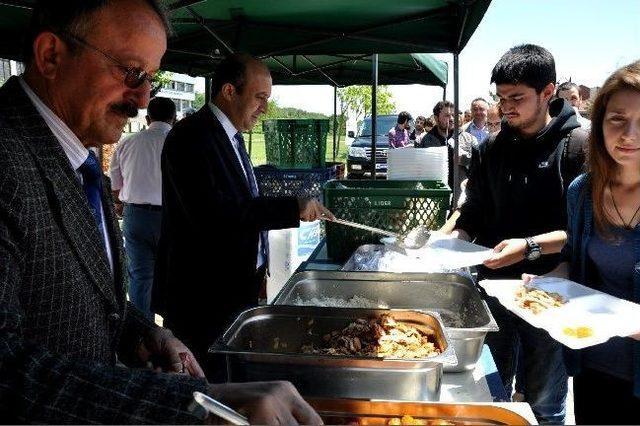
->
[109,121,171,206]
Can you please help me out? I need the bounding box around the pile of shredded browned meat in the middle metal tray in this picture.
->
[302,314,440,358]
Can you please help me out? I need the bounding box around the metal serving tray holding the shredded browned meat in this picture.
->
[209,306,456,401]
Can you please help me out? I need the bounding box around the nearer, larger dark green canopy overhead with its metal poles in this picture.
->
[0,0,491,192]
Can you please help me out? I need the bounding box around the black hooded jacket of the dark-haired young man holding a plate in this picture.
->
[456,99,588,278]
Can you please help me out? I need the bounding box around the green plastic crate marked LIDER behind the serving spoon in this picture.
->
[324,180,451,261]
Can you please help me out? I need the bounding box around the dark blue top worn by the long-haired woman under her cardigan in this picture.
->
[582,228,640,381]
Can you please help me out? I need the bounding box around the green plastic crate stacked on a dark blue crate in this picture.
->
[262,119,329,169]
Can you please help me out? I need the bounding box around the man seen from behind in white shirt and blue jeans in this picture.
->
[109,98,176,320]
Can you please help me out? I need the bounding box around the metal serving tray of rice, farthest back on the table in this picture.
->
[273,271,498,372]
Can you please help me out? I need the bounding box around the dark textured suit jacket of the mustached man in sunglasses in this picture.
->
[0,77,205,424]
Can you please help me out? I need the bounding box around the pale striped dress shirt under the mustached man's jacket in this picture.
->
[18,77,113,272]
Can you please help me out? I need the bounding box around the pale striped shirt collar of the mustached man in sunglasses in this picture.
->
[18,76,89,170]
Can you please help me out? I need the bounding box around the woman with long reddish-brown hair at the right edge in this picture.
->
[523,62,640,424]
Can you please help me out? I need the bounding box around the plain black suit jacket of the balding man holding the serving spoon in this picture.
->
[153,105,299,366]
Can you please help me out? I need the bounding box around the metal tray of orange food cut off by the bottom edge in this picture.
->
[308,399,530,425]
